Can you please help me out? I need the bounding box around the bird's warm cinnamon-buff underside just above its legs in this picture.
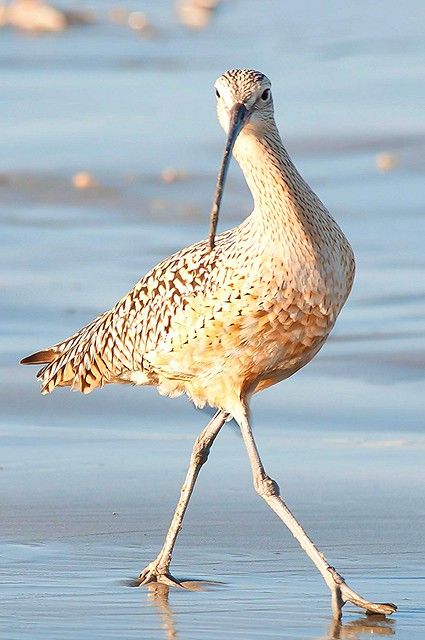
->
[144,294,334,410]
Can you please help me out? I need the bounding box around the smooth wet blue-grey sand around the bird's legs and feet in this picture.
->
[0,418,425,640]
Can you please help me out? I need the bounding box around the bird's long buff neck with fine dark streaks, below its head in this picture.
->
[234,126,354,308]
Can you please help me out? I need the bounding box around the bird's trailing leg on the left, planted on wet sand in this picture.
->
[136,411,228,587]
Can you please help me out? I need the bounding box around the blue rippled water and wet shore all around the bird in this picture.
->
[0,0,425,640]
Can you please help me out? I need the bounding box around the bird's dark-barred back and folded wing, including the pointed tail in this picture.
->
[22,228,252,393]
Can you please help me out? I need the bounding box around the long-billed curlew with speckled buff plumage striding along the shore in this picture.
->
[22,69,396,618]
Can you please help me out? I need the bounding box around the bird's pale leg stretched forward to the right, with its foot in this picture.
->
[235,408,397,619]
